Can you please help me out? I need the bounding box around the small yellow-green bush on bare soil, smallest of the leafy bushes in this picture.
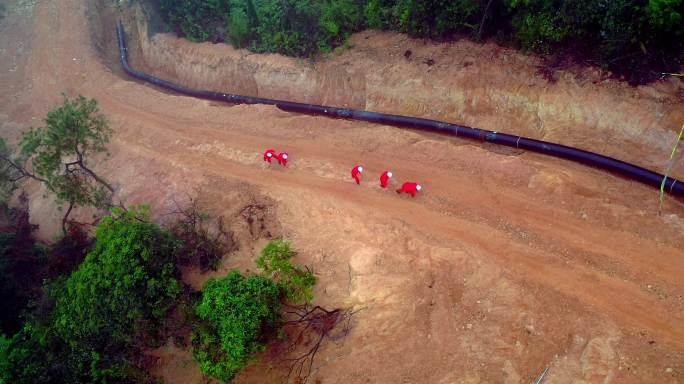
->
[256,240,316,303]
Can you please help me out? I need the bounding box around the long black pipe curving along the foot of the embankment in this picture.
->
[116,22,684,196]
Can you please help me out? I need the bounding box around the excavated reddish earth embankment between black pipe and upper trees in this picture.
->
[120,6,684,175]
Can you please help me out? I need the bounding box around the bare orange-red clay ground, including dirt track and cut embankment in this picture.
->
[0,0,684,384]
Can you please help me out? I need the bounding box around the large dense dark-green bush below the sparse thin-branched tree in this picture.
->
[54,207,180,381]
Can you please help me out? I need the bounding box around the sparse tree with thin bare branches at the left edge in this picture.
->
[0,96,114,233]
